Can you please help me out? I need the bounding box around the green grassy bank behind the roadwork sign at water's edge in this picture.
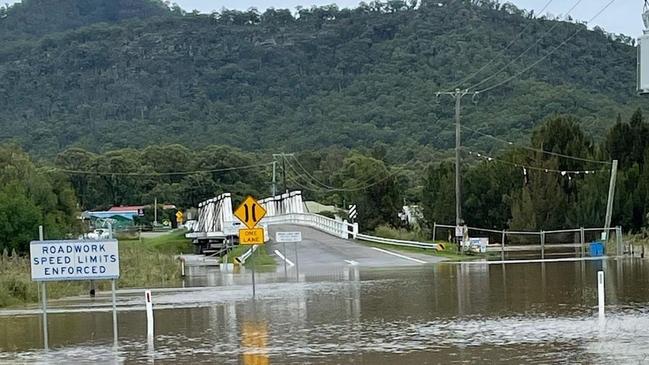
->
[0,231,192,307]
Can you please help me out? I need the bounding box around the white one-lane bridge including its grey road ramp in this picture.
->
[186,191,442,271]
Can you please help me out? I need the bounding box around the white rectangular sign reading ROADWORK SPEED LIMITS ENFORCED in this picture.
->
[29,240,119,281]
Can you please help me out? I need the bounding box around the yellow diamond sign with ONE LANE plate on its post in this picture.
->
[234,195,266,298]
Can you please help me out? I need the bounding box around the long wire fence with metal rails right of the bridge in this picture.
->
[433,223,625,261]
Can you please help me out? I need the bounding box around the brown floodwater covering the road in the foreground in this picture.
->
[0,259,649,365]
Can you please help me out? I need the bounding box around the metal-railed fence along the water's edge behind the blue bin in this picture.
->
[433,223,624,261]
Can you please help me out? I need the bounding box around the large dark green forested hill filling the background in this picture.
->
[0,0,642,160]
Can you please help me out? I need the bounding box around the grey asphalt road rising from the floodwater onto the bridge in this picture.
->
[268,225,444,271]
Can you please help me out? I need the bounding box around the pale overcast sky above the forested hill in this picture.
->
[1,0,644,37]
